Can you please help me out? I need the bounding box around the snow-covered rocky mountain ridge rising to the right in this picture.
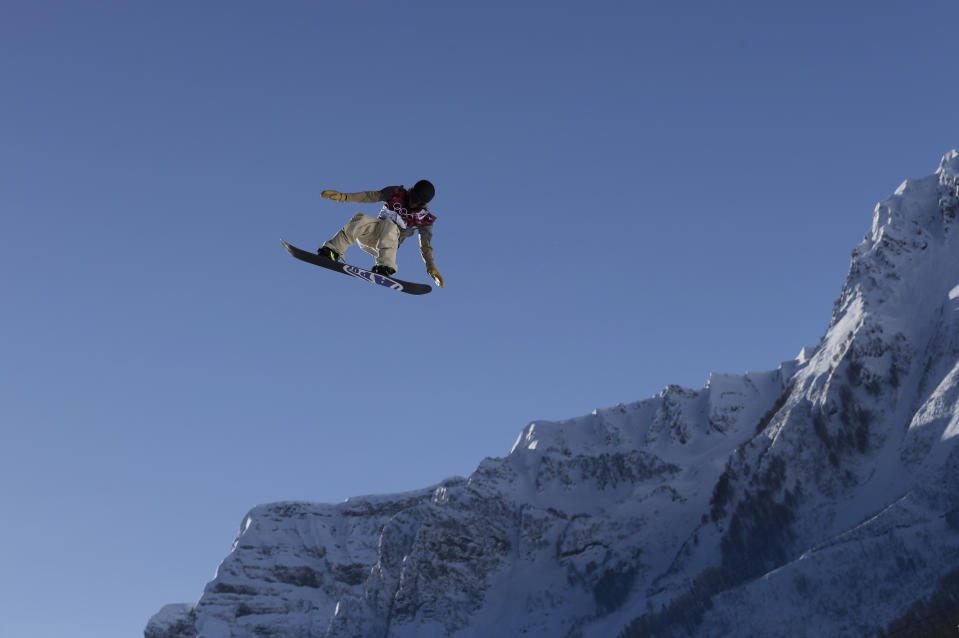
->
[146,151,959,638]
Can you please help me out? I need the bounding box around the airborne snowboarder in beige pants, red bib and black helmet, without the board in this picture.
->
[317,179,444,288]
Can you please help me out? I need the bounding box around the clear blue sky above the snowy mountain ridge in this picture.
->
[0,0,959,638]
